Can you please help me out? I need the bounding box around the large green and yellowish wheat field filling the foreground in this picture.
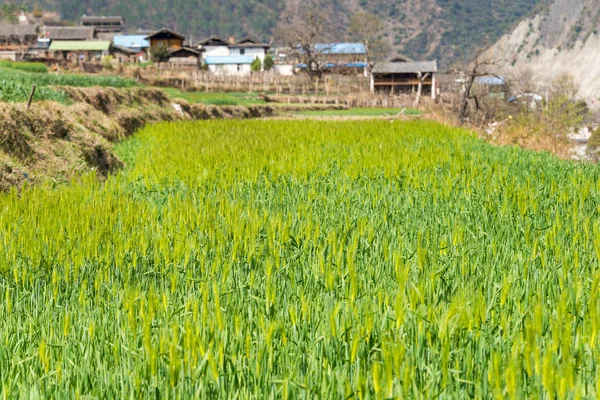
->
[0,121,600,399]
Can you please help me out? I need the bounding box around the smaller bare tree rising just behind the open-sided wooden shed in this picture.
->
[348,13,391,72]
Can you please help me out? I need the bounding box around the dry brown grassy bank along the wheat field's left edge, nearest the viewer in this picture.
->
[0,103,122,190]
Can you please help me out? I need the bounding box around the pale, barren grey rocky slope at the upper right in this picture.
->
[490,0,600,108]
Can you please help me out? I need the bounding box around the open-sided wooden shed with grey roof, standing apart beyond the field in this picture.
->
[371,57,437,99]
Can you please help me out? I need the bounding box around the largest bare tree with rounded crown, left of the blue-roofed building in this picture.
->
[274,1,330,81]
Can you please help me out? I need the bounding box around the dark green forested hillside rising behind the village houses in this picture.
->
[0,0,543,65]
